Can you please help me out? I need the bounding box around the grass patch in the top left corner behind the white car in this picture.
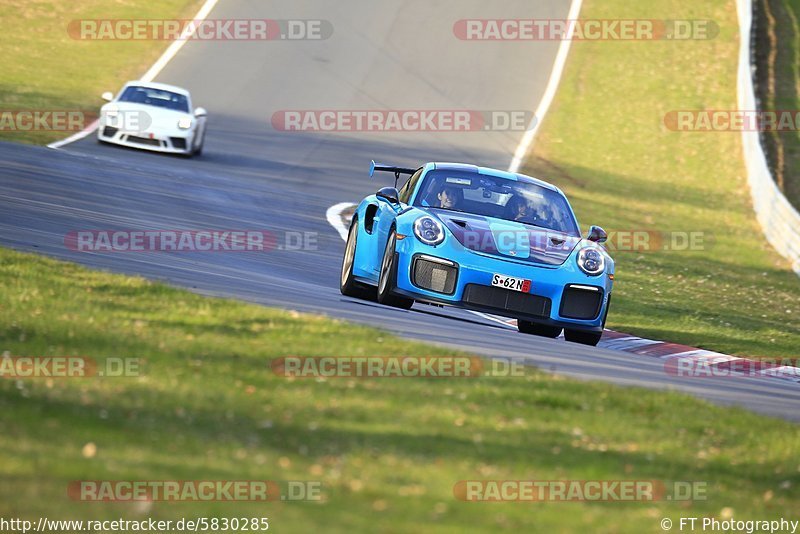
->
[0,0,200,144]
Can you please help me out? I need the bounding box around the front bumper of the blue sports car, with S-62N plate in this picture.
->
[395,235,613,332]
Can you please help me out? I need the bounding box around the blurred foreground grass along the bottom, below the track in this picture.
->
[0,249,800,532]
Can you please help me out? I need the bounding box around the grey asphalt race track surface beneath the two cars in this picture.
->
[0,0,800,420]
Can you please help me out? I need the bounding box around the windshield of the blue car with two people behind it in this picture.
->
[414,170,579,236]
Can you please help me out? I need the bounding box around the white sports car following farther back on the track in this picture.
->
[97,82,206,156]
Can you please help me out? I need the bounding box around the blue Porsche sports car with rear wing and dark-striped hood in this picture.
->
[340,161,614,345]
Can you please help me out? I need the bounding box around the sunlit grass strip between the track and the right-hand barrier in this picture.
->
[524,0,800,358]
